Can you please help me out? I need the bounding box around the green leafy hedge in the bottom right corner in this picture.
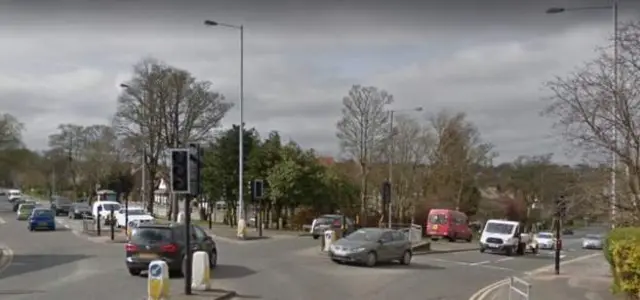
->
[604,227,640,299]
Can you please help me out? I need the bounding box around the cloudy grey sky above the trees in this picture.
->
[0,0,640,162]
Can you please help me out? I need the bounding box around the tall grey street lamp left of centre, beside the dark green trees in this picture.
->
[204,20,245,238]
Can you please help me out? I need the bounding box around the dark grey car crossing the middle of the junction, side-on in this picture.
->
[329,228,413,267]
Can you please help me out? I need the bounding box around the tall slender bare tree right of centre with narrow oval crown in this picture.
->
[337,85,393,224]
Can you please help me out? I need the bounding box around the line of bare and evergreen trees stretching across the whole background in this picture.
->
[0,23,640,230]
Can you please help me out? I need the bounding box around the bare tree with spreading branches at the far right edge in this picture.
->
[545,22,640,222]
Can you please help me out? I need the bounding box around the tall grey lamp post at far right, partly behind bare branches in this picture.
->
[546,0,620,228]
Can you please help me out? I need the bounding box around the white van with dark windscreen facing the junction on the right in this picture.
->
[480,220,538,256]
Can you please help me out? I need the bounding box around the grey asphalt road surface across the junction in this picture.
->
[0,198,600,300]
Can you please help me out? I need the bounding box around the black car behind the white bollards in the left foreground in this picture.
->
[125,223,218,276]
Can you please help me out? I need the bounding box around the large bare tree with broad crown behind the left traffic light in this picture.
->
[116,59,232,218]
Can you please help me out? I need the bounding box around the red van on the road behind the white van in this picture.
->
[426,209,473,242]
